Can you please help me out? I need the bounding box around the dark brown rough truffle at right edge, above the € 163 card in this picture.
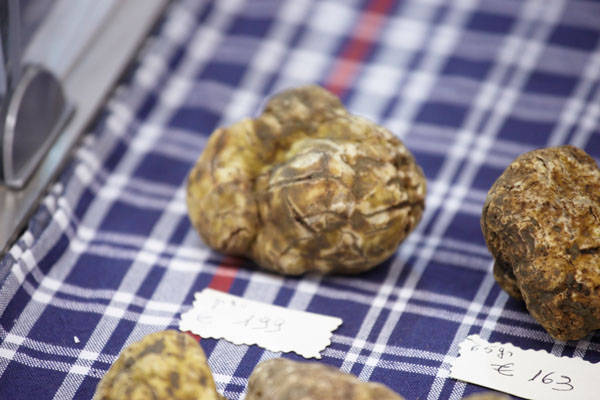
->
[481,146,600,340]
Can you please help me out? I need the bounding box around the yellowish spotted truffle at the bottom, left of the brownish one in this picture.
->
[94,330,224,400]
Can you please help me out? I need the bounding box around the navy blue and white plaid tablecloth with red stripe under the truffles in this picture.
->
[0,0,600,400]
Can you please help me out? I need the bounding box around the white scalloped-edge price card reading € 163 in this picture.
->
[450,335,600,400]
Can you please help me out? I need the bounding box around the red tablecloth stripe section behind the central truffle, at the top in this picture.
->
[325,0,396,97]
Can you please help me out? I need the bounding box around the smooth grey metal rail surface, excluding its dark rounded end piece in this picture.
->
[0,0,168,254]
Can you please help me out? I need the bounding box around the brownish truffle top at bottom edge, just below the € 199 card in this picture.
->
[246,358,402,400]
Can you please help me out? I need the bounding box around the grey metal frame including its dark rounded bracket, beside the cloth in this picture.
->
[0,0,168,260]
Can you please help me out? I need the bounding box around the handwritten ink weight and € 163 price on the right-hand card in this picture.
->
[467,338,575,392]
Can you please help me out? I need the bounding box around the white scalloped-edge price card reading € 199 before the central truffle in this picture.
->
[179,289,342,358]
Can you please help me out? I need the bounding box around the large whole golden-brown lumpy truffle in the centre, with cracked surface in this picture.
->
[187,86,425,274]
